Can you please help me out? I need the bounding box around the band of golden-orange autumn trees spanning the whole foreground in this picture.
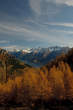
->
[0,62,73,104]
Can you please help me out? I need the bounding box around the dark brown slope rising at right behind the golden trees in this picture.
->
[45,49,73,70]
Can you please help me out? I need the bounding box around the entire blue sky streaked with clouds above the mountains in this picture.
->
[0,0,73,49]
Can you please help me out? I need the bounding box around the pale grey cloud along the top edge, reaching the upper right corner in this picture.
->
[29,0,73,15]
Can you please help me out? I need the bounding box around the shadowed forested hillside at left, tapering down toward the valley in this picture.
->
[0,49,29,82]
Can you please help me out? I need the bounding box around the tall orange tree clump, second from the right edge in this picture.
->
[49,66,65,99]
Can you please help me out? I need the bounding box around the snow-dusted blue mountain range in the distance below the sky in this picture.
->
[9,46,70,67]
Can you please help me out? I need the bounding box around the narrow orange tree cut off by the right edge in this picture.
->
[63,64,73,99]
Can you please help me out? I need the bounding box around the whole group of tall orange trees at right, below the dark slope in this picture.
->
[49,62,73,99]
